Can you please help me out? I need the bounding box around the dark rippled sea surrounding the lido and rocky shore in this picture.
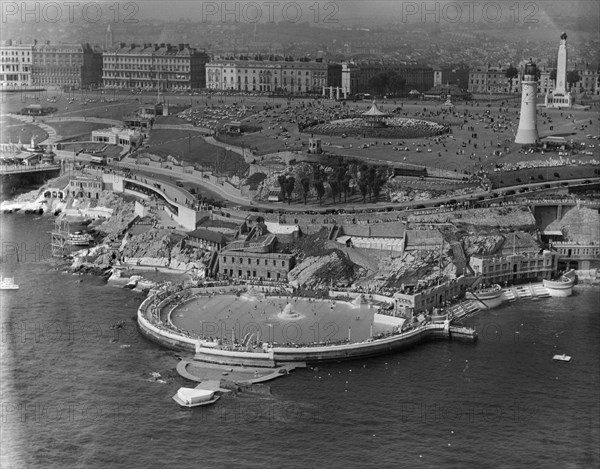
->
[0,214,600,468]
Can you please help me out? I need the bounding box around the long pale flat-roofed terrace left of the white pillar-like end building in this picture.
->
[206,59,342,94]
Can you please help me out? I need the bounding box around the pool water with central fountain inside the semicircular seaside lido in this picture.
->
[168,294,378,346]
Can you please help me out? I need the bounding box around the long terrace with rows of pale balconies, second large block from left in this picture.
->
[102,43,209,91]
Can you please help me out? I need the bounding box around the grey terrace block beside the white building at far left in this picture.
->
[31,41,102,90]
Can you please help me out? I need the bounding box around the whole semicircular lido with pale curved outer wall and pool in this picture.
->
[138,288,476,367]
